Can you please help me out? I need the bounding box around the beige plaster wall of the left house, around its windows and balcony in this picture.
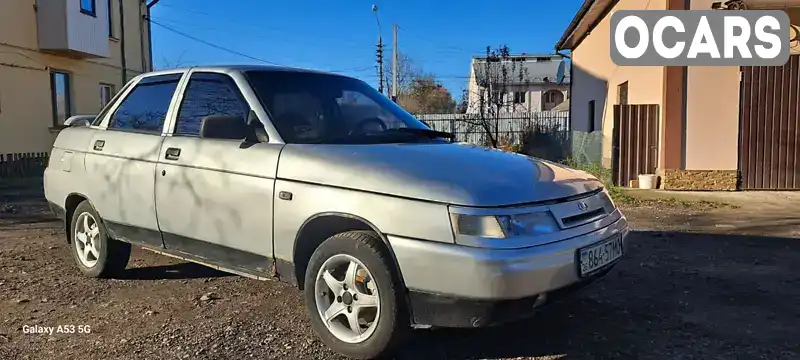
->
[0,0,150,154]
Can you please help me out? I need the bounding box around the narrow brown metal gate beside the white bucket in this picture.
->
[611,104,658,186]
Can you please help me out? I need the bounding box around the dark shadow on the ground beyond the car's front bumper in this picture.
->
[396,231,800,359]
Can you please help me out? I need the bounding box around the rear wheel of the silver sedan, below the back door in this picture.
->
[68,200,131,278]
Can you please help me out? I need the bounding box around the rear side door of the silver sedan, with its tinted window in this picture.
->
[85,73,182,247]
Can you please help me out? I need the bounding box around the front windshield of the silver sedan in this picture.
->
[246,71,447,144]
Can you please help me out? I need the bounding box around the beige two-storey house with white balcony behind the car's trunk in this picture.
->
[0,0,152,154]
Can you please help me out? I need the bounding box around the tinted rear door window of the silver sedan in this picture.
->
[108,74,181,134]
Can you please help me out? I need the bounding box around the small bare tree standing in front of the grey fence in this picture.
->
[461,45,529,148]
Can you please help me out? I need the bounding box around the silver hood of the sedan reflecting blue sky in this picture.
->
[278,143,602,207]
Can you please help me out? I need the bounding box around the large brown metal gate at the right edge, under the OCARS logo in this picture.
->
[739,55,800,190]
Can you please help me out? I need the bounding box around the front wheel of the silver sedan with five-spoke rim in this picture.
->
[304,231,411,359]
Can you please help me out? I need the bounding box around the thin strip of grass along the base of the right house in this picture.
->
[563,159,736,210]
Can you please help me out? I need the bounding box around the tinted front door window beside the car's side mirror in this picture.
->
[174,73,250,136]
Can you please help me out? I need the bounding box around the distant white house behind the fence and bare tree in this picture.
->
[467,54,570,114]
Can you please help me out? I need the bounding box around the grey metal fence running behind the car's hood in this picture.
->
[415,111,569,145]
